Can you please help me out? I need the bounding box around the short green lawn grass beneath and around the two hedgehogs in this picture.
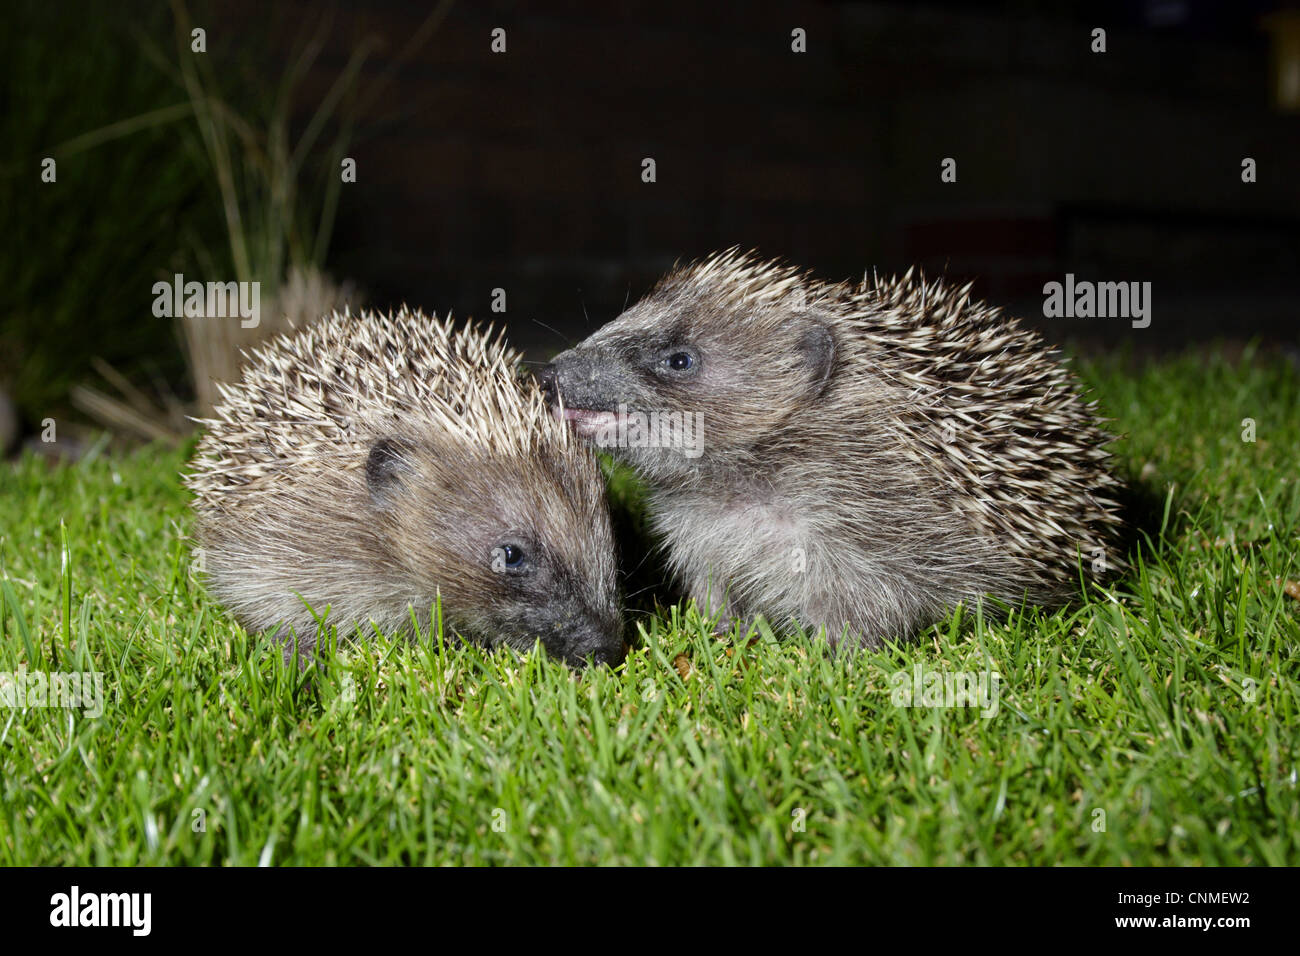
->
[0,354,1300,865]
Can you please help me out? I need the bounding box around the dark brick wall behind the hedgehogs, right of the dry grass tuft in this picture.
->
[306,0,1300,352]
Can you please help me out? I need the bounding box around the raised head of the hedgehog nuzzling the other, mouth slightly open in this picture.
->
[542,285,836,481]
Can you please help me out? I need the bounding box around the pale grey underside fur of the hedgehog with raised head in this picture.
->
[653,455,1019,641]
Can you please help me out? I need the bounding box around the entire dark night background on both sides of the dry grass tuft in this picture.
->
[0,0,1300,433]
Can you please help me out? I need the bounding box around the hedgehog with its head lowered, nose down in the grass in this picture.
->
[186,310,624,665]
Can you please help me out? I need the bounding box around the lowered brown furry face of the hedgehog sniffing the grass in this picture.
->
[365,436,625,665]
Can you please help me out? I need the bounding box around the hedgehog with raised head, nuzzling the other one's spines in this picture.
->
[542,250,1119,645]
